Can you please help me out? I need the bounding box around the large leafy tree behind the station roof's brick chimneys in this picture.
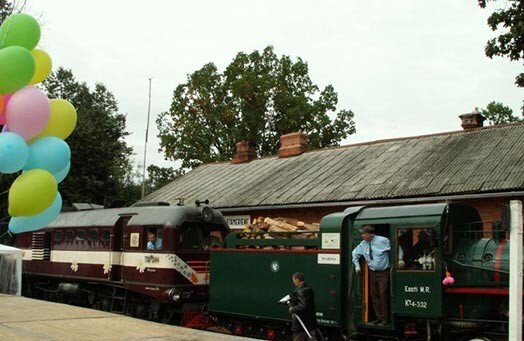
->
[156,46,355,170]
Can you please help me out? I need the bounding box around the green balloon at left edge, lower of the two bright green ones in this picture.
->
[0,46,35,95]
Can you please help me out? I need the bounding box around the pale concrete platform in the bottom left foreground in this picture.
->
[0,294,254,341]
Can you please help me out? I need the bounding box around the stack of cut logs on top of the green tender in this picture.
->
[243,217,320,239]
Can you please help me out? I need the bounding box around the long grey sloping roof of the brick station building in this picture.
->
[144,123,524,208]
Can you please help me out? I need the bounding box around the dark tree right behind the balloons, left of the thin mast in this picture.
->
[43,68,140,206]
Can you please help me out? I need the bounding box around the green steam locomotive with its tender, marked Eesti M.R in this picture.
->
[209,203,509,340]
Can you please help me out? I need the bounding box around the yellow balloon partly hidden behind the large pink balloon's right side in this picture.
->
[31,99,76,142]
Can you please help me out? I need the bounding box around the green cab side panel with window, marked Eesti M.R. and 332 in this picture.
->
[391,204,447,319]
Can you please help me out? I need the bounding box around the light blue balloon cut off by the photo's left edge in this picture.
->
[0,132,29,174]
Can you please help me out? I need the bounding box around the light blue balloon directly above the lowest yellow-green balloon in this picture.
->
[24,136,71,174]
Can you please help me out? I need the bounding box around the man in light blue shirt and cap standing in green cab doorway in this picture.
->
[352,225,391,326]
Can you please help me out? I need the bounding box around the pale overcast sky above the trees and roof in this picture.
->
[26,0,524,173]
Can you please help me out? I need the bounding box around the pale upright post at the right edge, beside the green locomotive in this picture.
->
[509,200,522,340]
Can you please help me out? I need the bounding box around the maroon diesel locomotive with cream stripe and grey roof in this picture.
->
[16,201,229,322]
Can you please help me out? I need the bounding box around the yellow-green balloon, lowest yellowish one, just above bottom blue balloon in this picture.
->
[8,169,58,217]
